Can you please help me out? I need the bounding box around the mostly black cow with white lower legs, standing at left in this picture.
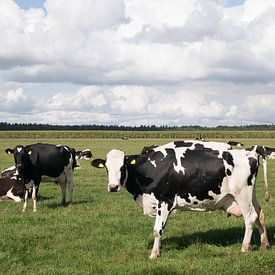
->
[6,143,76,212]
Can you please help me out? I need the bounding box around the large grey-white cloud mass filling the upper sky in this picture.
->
[0,0,275,85]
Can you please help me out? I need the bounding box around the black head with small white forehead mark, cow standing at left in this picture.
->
[5,145,32,175]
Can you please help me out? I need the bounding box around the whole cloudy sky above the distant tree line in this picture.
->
[0,0,275,127]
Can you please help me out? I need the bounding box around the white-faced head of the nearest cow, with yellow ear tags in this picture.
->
[91,149,137,192]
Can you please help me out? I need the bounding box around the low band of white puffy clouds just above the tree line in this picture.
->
[0,85,275,126]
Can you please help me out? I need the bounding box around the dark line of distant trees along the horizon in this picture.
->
[0,122,275,131]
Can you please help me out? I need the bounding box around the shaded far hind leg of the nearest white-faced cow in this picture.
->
[253,190,270,249]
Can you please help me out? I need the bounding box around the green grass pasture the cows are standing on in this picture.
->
[0,136,275,274]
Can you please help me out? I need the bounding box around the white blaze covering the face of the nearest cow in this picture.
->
[105,149,125,191]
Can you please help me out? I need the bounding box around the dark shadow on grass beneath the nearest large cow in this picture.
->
[148,226,275,250]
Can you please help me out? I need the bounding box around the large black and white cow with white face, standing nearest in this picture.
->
[92,141,269,259]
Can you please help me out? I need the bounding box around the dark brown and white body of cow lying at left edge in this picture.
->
[0,178,26,202]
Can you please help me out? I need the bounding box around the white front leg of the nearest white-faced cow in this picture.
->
[149,202,170,259]
